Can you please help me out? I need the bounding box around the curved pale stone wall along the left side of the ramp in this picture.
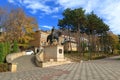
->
[6,51,25,63]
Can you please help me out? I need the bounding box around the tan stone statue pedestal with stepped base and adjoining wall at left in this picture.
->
[35,45,67,67]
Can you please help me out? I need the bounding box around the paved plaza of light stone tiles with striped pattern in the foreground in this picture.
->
[0,56,120,80]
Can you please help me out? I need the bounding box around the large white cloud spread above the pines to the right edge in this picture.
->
[56,0,120,34]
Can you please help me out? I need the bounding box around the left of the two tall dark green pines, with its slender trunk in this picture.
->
[58,8,86,51]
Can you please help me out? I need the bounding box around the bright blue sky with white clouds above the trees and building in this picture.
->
[0,0,120,34]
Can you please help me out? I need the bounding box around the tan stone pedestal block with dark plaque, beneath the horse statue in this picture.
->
[44,45,64,61]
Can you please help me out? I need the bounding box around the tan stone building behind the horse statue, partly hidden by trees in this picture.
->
[30,30,77,51]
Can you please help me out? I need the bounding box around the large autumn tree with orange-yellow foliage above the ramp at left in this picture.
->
[4,8,38,46]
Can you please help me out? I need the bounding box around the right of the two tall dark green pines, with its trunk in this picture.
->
[87,12,109,51]
